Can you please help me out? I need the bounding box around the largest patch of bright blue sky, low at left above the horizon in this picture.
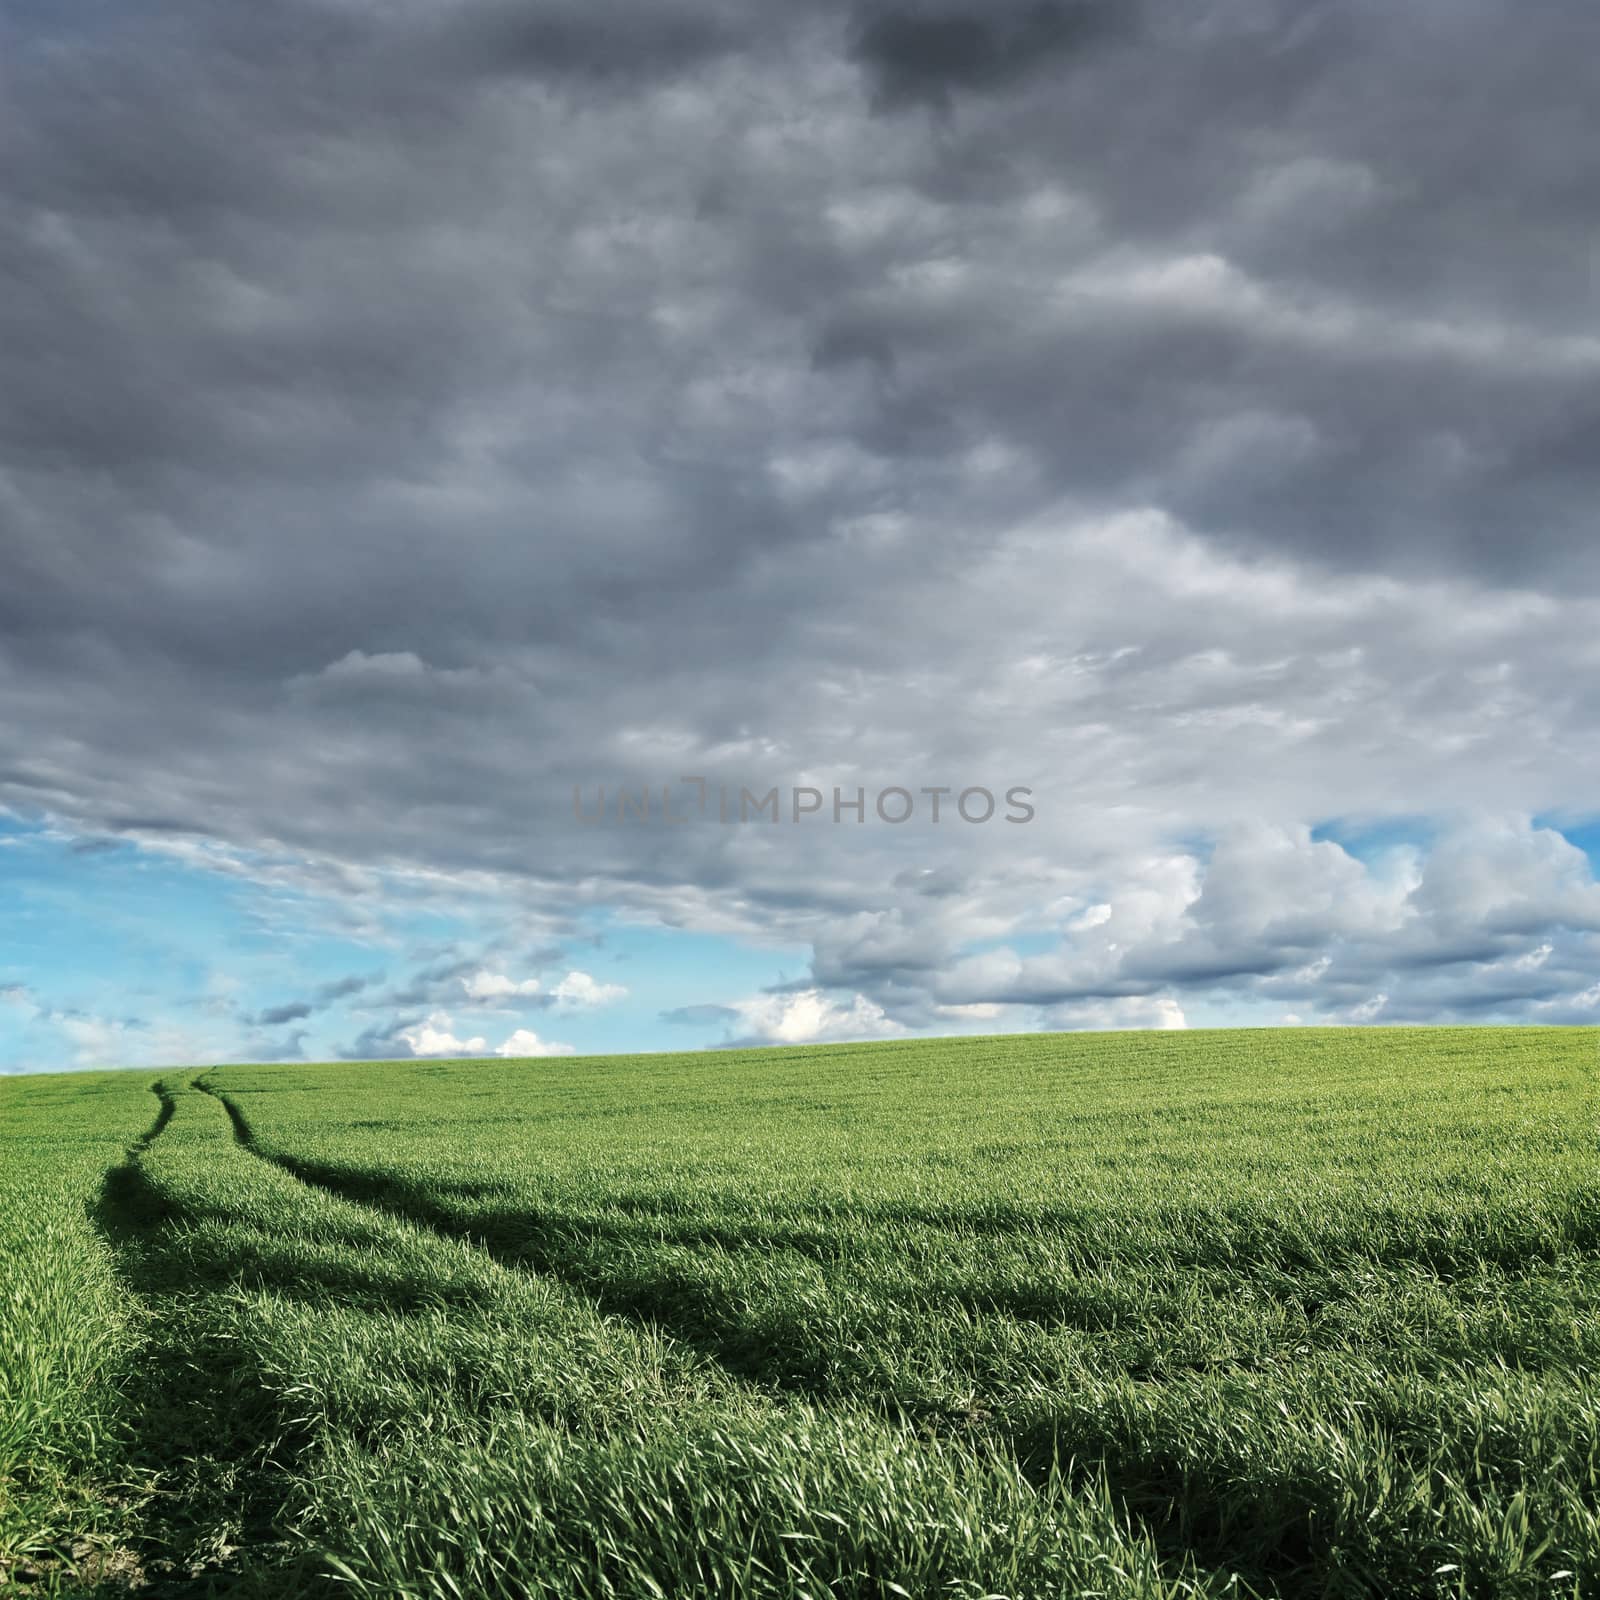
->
[0,814,810,1070]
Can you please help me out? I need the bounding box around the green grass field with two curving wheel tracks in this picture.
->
[0,1029,1600,1600]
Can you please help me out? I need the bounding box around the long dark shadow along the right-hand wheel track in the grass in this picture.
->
[208,1091,1542,1600]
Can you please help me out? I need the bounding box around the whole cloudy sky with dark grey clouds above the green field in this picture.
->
[0,0,1600,1072]
